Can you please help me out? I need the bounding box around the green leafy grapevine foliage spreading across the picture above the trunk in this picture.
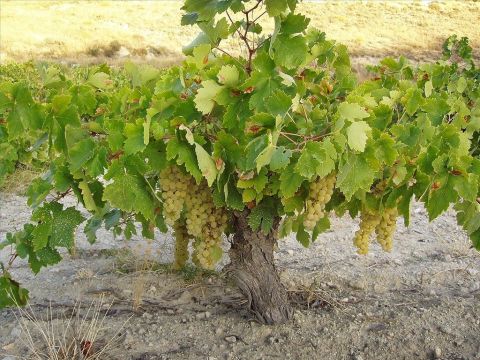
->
[0,0,480,306]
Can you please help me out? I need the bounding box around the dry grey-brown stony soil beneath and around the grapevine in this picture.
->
[0,193,480,360]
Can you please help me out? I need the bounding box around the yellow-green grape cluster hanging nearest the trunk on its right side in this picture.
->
[303,172,336,231]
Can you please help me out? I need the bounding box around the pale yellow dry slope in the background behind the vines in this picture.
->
[0,0,480,65]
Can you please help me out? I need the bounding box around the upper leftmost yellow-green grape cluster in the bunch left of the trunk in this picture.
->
[159,166,193,225]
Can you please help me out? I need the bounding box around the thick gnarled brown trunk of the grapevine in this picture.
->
[229,211,293,324]
